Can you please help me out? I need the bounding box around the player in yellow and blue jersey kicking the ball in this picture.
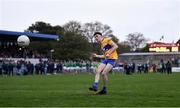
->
[89,32,118,95]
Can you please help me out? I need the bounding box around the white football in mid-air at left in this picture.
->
[17,35,30,46]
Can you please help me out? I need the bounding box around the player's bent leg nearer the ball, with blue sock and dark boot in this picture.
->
[89,63,106,91]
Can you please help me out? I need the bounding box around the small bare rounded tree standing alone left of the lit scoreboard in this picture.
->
[127,33,147,51]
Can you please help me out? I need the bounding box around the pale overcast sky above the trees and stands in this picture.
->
[0,0,180,43]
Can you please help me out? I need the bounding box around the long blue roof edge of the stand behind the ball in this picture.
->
[0,30,59,40]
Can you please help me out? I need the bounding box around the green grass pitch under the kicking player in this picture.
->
[0,73,180,107]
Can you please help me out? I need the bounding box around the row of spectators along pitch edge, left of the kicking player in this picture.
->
[0,59,97,76]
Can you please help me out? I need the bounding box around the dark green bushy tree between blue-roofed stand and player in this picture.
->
[55,32,90,60]
